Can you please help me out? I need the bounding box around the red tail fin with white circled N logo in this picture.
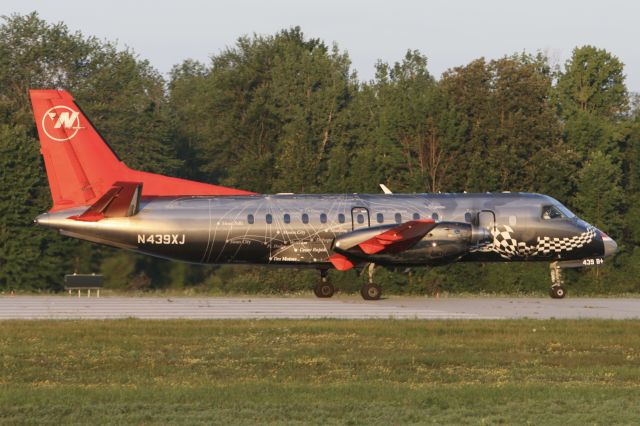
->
[29,90,253,211]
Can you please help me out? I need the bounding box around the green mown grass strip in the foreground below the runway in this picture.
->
[0,320,640,425]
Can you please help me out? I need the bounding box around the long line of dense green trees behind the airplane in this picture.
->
[0,12,640,293]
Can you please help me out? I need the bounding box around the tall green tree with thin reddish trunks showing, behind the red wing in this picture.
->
[364,51,463,192]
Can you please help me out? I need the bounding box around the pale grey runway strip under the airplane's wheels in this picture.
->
[0,295,640,320]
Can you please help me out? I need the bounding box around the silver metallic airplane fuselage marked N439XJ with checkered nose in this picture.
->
[36,193,616,268]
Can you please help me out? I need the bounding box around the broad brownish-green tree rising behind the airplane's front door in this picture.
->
[440,54,570,191]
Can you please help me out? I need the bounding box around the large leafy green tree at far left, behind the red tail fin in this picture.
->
[0,12,180,289]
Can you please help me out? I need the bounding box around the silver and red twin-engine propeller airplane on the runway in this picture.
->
[30,90,617,300]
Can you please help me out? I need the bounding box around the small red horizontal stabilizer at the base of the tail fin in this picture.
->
[69,182,142,222]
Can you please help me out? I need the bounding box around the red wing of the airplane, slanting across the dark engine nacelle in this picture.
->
[358,219,436,254]
